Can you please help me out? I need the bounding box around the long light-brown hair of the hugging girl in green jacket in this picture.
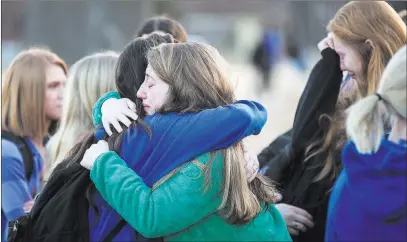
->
[148,43,274,224]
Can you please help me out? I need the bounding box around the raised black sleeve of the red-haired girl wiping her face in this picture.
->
[292,48,342,152]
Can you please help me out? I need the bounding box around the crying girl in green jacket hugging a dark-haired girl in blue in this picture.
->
[81,40,291,241]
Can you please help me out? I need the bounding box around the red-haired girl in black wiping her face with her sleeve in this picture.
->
[259,1,406,241]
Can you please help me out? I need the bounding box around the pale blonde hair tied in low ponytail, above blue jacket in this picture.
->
[346,46,407,153]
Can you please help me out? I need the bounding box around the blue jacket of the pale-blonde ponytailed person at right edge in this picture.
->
[325,138,407,241]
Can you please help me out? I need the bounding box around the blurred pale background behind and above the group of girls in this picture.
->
[1,0,406,151]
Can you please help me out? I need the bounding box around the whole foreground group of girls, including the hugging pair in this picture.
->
[1,1,407,242]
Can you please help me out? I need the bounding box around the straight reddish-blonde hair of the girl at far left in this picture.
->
[1,48,67,138]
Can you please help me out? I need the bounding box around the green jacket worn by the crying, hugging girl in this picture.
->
[91,151,291,241]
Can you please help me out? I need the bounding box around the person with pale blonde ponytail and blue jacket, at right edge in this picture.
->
[325,46,407,241]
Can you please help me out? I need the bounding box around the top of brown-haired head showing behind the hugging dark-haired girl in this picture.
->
[137,16,187,42]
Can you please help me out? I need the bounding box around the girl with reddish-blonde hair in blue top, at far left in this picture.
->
[1,48,67,241]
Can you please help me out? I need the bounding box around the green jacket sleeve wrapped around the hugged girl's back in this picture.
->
[91,151,221,238]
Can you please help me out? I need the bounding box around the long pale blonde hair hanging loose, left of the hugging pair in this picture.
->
[46,51,119,177]
